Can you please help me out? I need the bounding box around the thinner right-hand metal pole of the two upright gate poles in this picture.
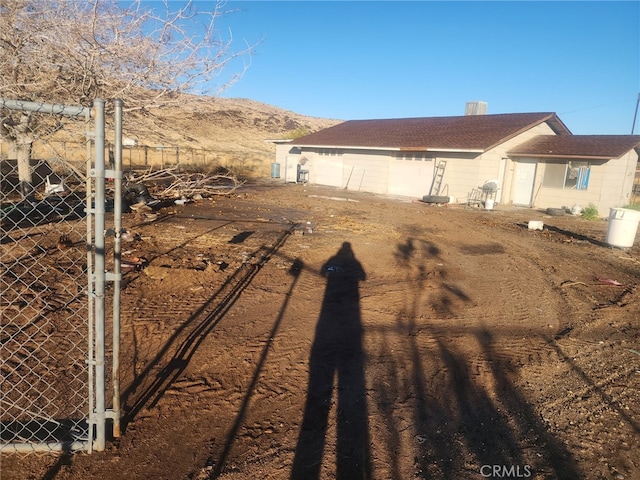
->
[112,99,124,438]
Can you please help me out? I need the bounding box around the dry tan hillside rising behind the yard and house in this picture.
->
[6,93,342,176]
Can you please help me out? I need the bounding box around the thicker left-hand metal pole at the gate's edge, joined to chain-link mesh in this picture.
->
[93,99,106,452]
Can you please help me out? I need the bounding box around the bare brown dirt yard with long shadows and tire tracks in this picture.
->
[1,180,640,480]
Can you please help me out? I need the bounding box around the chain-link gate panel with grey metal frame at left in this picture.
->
[0,99,121,452]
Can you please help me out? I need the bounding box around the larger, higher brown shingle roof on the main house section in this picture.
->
[291,113,571,151]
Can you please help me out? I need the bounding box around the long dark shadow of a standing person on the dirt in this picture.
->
[291,242,371,480]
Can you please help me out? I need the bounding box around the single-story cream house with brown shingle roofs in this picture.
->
[275,112,640,215]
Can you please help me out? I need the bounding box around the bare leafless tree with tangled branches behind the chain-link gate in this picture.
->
[0,0,254,196]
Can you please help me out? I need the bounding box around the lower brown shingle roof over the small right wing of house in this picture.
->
[509,135,640,160]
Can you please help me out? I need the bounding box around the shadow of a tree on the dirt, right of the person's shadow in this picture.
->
[374,238,583,480]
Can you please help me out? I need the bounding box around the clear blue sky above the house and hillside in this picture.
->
[211,1,640,134]
